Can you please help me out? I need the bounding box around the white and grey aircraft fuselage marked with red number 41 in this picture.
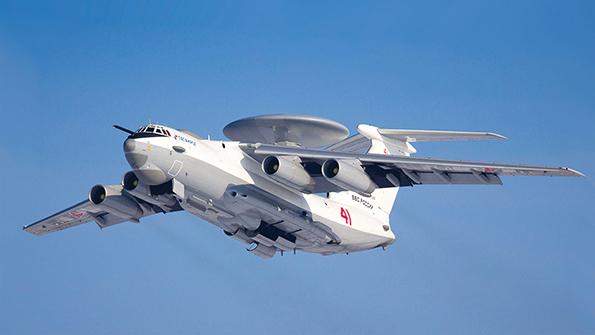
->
[124,127,395,254]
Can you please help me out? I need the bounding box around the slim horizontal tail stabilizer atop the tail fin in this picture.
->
[378,128,506,142]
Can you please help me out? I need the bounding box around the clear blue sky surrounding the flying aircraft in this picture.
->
[0,1,595,334]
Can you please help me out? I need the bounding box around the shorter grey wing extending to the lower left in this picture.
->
[23,185,178,235]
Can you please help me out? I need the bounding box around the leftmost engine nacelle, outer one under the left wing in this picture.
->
[89,185,143,219]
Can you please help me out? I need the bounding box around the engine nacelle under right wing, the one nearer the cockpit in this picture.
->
[262,156,314,191]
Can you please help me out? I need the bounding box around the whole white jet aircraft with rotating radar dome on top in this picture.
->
[23,115,582,258]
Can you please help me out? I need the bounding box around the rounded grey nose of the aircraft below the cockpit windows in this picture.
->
[124,138,169,185]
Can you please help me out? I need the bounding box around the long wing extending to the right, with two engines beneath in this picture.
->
[243,144,582,192]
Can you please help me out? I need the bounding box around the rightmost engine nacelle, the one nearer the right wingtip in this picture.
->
[322,159,378,197]
